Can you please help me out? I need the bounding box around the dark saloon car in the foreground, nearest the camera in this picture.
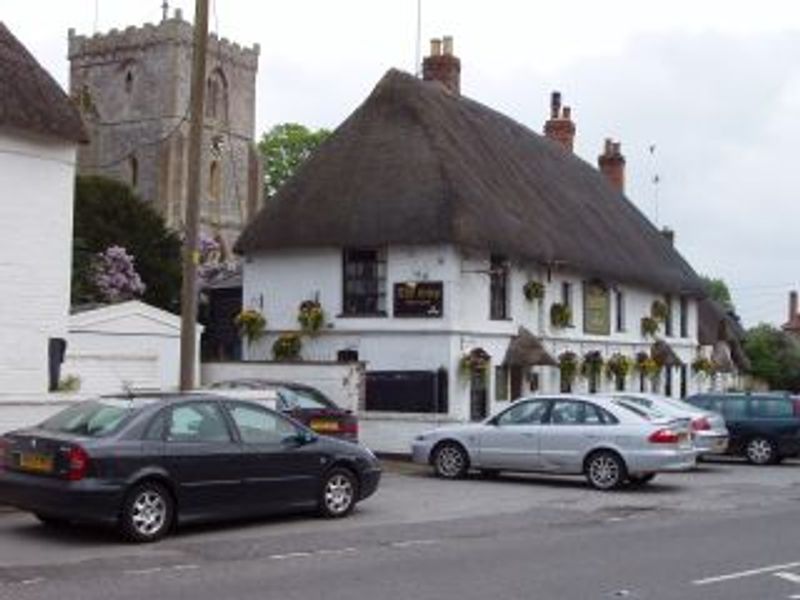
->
[0,394,381,542]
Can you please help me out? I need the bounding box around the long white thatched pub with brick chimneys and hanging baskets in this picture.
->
[237,40,703,450]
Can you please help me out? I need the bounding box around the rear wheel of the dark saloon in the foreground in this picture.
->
[120,481,175,543]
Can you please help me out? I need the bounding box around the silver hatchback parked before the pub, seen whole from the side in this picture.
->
[412,395,696,490]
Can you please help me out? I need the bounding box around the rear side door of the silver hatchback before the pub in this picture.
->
[539,399,607,473]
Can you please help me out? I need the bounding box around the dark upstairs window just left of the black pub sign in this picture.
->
[339,246,388,318]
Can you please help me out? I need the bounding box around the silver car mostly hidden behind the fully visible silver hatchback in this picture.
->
[608,392,729,457]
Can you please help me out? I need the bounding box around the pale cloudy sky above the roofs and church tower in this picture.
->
[0,0,800,326]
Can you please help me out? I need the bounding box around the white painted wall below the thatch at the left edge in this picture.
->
[0,129,76,396]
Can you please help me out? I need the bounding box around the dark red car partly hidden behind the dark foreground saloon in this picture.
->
[208,379,358,442]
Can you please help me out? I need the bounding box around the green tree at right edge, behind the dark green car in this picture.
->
[744,323,800,392]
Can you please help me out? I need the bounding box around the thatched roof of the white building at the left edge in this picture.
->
[0,22,88,142]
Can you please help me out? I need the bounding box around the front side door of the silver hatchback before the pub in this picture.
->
[478,399,549,471]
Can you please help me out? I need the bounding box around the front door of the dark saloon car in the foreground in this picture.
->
[225,401,327,513]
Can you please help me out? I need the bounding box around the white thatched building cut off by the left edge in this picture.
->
[0,23,85,400]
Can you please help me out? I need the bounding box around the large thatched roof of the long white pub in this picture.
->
[236,70,702,295]
